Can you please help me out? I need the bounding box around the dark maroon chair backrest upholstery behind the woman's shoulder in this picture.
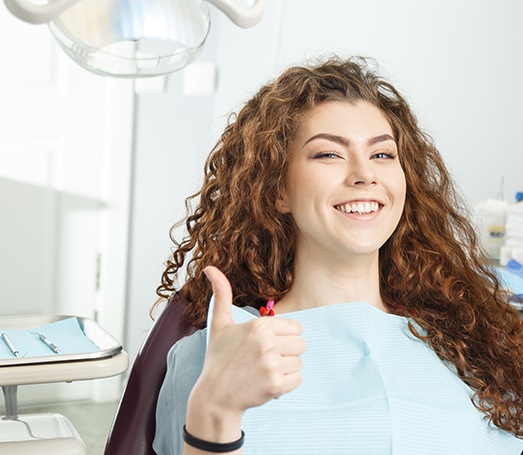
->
[104,293,197,455]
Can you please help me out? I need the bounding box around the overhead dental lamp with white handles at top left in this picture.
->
[4,0,265,78]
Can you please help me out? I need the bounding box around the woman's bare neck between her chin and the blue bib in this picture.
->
[275,253,387,313]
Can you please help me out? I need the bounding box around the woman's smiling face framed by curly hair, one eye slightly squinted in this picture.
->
[278,101,406,260]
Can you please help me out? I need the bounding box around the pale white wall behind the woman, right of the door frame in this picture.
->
[126,0,523,364]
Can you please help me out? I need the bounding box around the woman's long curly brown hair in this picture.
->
[157,57,523,437]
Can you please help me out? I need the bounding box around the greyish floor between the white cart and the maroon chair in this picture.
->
[19,402,118,455]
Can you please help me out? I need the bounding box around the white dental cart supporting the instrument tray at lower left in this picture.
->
[0,316,128,455]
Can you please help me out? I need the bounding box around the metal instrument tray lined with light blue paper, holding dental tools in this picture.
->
[0,315,123,369]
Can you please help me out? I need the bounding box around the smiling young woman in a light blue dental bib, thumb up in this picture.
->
[154,58,523,455]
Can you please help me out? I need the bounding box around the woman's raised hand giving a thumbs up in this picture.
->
[189,267,305,430]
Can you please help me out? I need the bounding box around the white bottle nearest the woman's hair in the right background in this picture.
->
[475,199,508,261]
